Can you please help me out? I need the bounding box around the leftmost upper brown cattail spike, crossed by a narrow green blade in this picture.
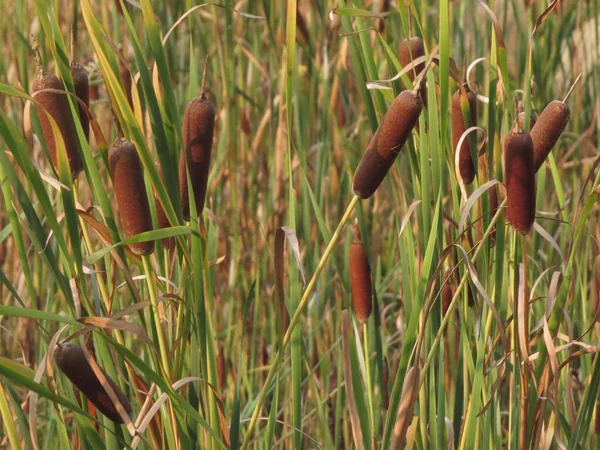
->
[33,72,82,179]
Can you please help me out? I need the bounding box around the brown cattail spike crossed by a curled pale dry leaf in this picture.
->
[452,84,477,184]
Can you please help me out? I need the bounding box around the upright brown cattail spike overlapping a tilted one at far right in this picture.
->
[504,125,535,234]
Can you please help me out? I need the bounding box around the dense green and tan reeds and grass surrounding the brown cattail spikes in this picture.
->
[0,0,600,450]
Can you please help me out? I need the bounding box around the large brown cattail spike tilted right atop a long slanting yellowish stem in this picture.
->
[352,90,423,199]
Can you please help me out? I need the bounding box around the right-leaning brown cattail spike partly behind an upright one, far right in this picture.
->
[531,100,571,172]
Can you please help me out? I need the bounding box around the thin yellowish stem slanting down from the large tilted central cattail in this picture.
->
[241,195,360,450]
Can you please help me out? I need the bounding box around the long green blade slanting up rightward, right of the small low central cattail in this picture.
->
[381,195,442,450]
